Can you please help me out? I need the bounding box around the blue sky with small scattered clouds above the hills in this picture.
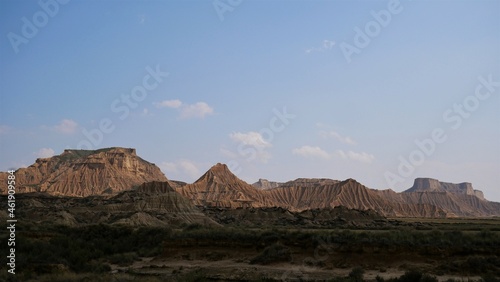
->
[0,0,500,201]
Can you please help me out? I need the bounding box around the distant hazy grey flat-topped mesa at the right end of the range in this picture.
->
[405,178,484,200]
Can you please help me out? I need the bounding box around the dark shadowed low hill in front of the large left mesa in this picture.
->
[0,182,218,227]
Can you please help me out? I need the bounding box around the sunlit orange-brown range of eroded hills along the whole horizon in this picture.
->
[0,148,500,221]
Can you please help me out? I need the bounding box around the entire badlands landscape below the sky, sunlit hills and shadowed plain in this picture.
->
[0,147,500,281]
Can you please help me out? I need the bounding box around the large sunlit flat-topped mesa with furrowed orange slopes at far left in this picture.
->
[0,148,168,197]
